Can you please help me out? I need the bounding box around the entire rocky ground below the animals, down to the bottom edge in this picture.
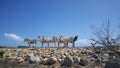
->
[0,48,120,68]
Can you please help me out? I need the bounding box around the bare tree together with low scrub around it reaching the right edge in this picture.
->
[90,20,120,49]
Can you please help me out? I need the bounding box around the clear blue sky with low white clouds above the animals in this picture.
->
[0,0,120,46]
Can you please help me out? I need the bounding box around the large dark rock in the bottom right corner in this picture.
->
[105,59,120,68]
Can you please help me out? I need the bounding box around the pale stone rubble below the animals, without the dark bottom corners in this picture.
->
[0,48,120,68]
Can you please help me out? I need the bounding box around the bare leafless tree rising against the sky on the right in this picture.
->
[92,20,116,47]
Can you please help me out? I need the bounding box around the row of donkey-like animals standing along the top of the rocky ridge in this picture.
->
[24,36,78,48]
